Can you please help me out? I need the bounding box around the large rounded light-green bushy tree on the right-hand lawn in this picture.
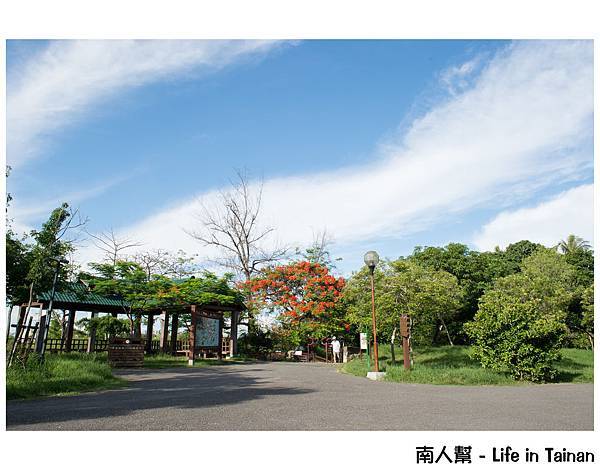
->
[466,249,575,381]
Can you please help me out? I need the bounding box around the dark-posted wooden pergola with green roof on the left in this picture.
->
[16,281,246,359]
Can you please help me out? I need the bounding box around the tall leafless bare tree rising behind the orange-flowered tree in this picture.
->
[187,171,288,280]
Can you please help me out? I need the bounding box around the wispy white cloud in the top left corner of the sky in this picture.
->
[7,40,276,167]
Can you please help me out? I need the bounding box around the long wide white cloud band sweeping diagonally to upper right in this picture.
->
[70,41,593,268]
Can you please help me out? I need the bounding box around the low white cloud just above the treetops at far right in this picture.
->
[474,184,594,250]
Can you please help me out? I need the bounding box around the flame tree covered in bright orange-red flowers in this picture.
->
[245,261,348,344]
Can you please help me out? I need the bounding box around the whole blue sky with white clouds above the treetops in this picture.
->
[7,40,593,273]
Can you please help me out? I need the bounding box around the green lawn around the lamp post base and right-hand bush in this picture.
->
[341,345,594,385]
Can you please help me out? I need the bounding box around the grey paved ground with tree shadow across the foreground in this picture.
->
[6,363,593,430]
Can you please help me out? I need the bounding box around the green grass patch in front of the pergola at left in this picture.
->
[6,353,126,400]
